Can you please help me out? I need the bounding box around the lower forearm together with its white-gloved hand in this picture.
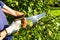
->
[0,20,21,40]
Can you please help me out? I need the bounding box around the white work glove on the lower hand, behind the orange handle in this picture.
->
[6,20,21,35]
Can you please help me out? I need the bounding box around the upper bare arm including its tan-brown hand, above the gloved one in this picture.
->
[2,5,24,16]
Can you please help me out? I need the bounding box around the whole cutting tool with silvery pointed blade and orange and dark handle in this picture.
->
[14,13,46,28]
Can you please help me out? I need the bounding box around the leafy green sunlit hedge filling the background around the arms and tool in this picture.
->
[3,0,60,40]
